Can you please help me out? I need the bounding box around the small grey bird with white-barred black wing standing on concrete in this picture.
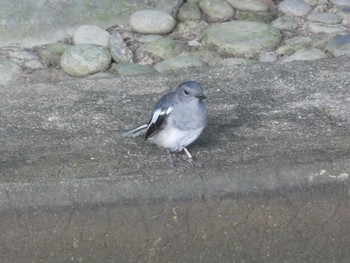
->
[123,81,207,167]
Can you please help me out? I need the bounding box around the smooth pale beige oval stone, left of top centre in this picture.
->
[129,10,176,35]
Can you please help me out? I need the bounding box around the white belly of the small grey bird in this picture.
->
[149,126,204,152]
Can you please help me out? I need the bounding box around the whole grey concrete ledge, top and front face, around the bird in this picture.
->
[0,58,350,262]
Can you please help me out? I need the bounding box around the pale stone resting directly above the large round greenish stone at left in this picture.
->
[73,25,110,47]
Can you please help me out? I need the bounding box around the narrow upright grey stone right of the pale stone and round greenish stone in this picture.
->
[108,32,134,62]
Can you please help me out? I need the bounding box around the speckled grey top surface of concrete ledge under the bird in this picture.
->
[0,59,350,211]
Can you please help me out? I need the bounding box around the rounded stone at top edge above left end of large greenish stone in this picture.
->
[199,0,235,22]
